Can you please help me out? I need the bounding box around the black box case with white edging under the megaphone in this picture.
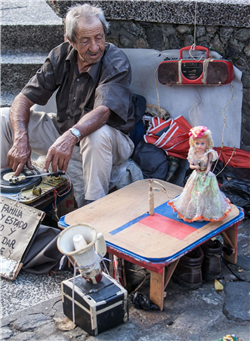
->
[62,273,128,335]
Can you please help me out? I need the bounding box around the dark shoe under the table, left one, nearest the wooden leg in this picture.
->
[173,247,204,289]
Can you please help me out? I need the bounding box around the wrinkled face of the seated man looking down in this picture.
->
[75,18,105,64]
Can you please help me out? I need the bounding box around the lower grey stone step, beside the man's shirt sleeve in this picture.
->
[0,51,48,107]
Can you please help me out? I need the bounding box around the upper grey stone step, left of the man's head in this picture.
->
[0,0,63,52]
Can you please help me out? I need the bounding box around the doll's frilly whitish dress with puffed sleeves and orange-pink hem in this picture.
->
[168,147,231,222]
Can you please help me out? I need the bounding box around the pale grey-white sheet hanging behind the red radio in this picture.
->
[123,49,243,148]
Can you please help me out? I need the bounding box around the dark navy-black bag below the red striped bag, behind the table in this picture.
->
[132,140,168,180]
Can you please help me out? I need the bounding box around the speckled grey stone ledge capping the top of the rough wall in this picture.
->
[45,0,250,27]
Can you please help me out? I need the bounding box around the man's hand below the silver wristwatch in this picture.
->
[44,131,77,172]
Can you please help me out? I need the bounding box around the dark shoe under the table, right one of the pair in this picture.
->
[201,239,223,280]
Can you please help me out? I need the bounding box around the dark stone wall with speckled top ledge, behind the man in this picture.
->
[46,0,250,151]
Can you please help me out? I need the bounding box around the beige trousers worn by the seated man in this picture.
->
[0,108,134,207]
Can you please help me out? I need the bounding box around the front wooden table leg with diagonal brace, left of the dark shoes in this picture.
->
[149,259,179,310]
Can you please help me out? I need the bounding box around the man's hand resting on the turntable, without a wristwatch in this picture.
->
[7,138,33,176]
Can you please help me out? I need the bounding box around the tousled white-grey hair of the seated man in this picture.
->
[65,4,109,43]
